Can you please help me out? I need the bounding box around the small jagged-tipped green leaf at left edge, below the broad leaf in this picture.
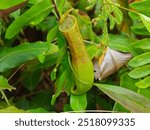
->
[0,75,15,91]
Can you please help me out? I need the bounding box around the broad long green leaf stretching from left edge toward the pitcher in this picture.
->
[0,42,58,72]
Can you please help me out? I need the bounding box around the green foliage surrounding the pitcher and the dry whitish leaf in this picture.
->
[0,0,150,113]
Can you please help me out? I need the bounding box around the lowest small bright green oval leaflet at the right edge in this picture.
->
[135,76,150,89]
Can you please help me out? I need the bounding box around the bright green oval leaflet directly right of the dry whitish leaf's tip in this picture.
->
[128,52,150,67]
